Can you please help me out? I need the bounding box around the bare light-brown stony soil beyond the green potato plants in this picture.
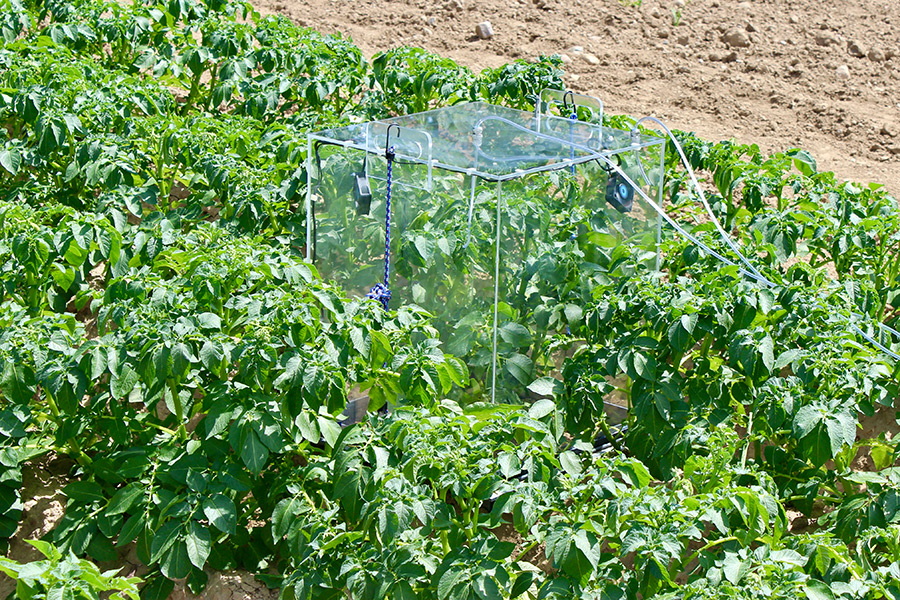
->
[255,0,900,196]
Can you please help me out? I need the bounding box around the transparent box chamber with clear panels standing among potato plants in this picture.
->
[306,90,665,401]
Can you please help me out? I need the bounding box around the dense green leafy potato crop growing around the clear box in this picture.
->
[0,0,900,600]
